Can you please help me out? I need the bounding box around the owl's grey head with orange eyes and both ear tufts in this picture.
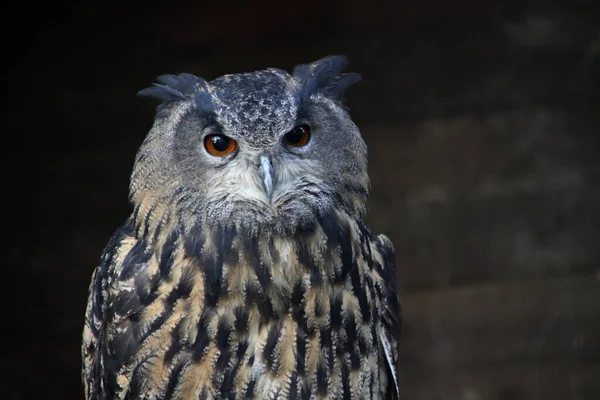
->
[130,56,369,232]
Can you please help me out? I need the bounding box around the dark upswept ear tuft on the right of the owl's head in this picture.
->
[294,56,362,99]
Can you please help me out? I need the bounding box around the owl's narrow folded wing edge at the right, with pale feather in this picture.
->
[373,235,401,399]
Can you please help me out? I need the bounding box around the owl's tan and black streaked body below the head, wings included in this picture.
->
[83,212,400,400]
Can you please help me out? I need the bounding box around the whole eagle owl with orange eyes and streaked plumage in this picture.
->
[82,56,400,399]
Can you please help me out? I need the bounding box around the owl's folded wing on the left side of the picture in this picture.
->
[82,221,152,400]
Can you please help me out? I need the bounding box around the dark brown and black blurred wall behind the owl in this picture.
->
[0,0,600,400]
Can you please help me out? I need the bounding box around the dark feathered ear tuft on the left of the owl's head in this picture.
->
[138,73,210,104]
